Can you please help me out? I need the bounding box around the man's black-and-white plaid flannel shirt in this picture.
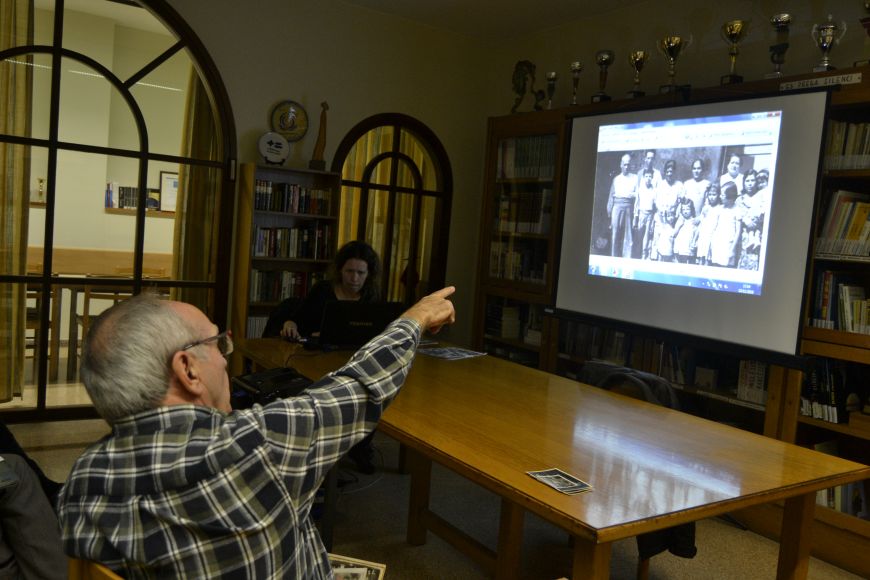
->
[58,319,420,580]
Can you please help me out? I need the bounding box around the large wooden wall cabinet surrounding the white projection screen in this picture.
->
[474,68,870,577]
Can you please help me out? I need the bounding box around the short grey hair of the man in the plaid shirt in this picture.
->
[81,293,199,424]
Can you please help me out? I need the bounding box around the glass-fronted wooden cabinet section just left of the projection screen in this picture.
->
[474,110,566,368]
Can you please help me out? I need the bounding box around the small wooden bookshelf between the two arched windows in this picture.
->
[231,163,341,368]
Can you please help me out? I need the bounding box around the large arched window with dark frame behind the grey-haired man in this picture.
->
[0,0,235,418]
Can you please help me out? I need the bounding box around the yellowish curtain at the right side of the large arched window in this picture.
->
[172,69,222,316]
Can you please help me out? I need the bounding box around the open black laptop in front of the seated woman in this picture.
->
[316,300,405,350]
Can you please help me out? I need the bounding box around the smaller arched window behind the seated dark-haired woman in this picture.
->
[333,114,453,303]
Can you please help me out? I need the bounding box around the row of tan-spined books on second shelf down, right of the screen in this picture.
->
[816,190,870,257]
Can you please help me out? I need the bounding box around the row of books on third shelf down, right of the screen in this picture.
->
[809,270,870,334]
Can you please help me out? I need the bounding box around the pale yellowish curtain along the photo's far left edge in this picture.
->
[0,0,33,402]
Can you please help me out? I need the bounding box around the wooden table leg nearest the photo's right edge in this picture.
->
[776,492,816,580]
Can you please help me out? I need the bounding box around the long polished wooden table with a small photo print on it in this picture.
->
[242,339,870,579]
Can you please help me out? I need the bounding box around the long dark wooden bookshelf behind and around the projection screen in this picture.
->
[474,68,870,577]
